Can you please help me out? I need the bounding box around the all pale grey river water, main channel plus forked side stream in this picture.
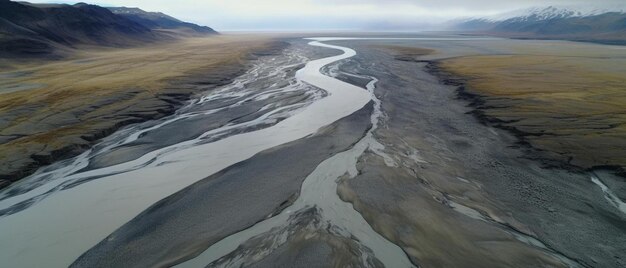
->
[0,38,612,267]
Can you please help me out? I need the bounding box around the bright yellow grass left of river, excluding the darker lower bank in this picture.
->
[0,36,269,111]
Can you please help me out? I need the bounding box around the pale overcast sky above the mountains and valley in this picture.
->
[31,0,626,31]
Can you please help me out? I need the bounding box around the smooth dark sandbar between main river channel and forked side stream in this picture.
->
[72,101,372,267]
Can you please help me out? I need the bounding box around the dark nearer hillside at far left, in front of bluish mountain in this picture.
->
[0,0,157,56]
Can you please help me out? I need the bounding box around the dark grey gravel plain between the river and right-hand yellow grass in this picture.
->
[335,41,626,267]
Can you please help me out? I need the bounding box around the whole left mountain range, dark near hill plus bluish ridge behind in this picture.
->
[0,0,215,58]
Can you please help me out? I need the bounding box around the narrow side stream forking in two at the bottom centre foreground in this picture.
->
[177,47,414,267]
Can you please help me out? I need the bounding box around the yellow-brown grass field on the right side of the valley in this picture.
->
[440,43,626,172]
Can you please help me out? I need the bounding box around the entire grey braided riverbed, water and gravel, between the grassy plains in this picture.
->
[0,36,626,267]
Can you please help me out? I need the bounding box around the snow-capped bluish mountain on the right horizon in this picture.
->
[453,6,626,44]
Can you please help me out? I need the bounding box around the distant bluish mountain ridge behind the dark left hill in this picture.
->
[108,7,217,34]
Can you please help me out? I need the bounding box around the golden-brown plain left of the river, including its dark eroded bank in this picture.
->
[0,35,285,188]
